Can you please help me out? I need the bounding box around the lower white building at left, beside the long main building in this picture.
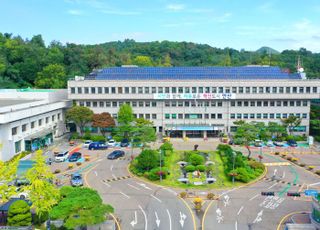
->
[0,89,71,161]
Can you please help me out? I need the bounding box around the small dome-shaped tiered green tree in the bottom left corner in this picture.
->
[8,200,32,227]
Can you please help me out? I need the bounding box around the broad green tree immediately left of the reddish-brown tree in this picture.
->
[66,106,93,136]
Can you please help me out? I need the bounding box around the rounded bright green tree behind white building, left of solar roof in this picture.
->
[35,64,67,89]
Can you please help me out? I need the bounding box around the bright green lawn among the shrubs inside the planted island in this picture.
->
[151,151,243,189]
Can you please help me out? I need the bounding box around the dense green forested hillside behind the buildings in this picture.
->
[0,33,320,88]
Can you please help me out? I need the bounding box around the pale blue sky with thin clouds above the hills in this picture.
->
[0,0,320,52]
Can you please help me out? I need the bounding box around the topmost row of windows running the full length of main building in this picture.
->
[70,86,319,94]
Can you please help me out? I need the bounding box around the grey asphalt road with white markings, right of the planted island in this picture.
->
[202,149,319,230]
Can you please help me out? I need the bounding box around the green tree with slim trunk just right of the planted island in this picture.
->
[233,120,259,159]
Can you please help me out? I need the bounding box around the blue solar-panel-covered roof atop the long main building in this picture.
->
[86,66,301,80]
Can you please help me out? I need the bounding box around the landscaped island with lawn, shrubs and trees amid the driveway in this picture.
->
[130,142,264,189]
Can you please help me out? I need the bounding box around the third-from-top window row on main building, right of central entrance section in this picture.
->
[230,113,308,119]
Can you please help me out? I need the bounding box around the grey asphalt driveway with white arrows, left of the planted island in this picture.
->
[86,147,194,230]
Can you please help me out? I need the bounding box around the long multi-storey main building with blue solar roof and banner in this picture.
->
[68,66,320,138]
